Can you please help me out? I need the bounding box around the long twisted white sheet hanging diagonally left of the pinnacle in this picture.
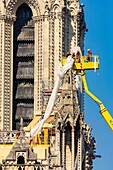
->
[26,55,74,137]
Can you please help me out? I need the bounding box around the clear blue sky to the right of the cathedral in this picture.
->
[81,0,113,170]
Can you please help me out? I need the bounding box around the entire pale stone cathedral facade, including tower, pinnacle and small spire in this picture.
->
[0,0,99,170]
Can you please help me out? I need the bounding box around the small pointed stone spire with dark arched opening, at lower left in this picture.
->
[3,118,37,164]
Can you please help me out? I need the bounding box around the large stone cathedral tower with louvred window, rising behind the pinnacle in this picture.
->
[0,0,86,130]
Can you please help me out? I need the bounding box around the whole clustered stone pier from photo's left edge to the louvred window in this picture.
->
[0,15,15,130]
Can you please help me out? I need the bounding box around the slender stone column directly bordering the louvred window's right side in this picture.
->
[33,16,42,115]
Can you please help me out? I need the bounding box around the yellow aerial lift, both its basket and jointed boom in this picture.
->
[61,56,113,131]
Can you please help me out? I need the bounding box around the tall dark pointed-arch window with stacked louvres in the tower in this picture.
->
[13,3,34,129]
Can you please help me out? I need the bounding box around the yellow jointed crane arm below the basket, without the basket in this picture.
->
[79,72,113,131]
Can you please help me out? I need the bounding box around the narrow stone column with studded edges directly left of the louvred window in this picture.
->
[3,16,15,130]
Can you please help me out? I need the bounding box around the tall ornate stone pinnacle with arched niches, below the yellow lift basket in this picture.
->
[51,71,95,170]
